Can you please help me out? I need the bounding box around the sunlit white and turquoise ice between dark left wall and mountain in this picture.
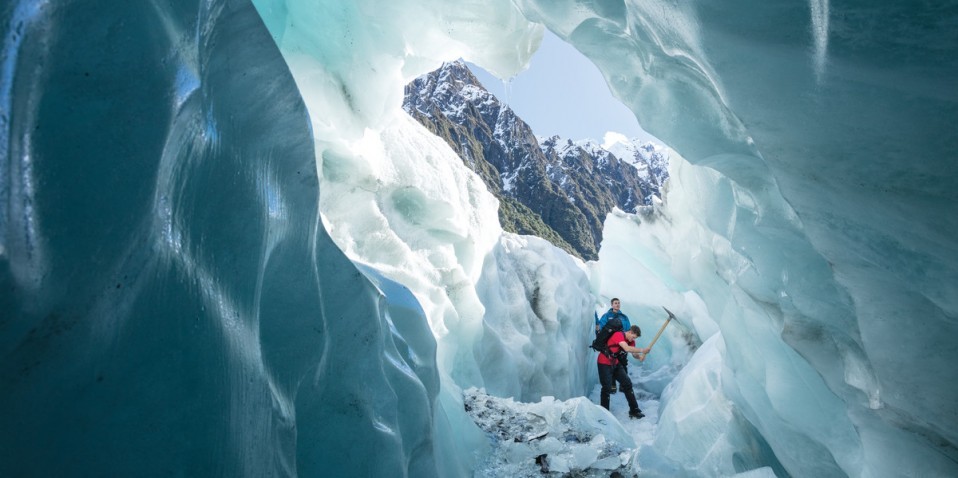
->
[255,0,593,413]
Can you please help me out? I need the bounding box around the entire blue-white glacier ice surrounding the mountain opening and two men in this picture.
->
[0,0,958,477]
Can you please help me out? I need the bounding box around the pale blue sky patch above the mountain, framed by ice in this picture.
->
[469,30,653,143]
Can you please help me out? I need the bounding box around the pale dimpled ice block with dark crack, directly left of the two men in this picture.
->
[475,233,596,402]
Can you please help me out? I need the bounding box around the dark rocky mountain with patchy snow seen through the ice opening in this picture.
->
[403,62,665,260]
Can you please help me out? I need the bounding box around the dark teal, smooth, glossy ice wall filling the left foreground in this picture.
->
[0,0,464,476]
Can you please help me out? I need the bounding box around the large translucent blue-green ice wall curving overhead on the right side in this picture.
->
[540,0,958,476]
